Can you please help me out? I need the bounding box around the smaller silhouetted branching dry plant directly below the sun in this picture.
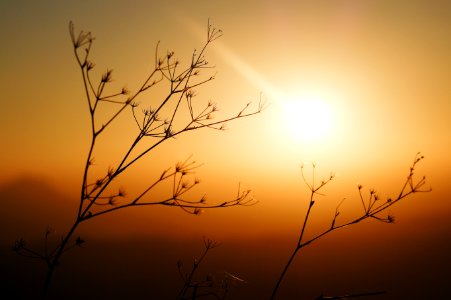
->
[270,153,431,299]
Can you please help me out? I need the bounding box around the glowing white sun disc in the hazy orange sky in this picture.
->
[282,96,333,142]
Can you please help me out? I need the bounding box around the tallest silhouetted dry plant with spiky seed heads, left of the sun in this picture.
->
[14,22,264,298]
